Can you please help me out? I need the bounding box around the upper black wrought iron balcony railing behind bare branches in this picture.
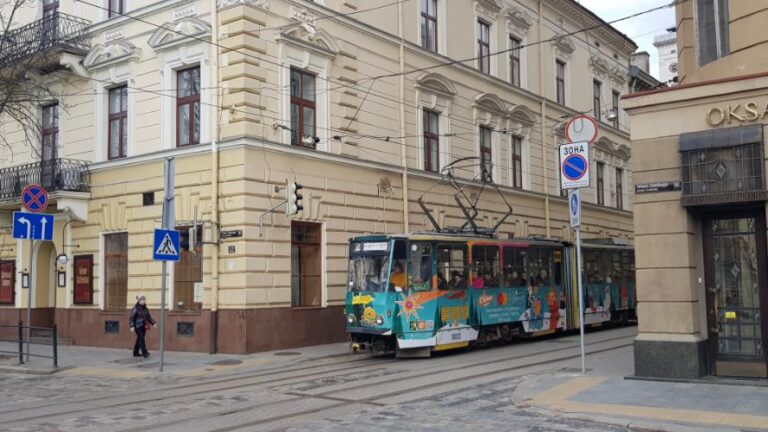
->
[0,12,91,66]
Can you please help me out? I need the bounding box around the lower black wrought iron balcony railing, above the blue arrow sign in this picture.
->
[0,159,91,201]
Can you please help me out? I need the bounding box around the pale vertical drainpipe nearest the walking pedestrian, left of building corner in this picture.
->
[209,0,221,354]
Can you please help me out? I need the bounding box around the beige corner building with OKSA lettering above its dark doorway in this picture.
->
[624,0,768,378]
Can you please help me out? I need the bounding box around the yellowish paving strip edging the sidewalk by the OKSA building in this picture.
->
[531,377,768,429]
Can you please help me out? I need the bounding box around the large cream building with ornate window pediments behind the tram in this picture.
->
[0,0,636,353]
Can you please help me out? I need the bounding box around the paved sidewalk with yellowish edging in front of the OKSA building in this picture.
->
[528,371,768,431]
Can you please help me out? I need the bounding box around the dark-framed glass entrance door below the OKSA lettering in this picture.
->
[704,210,768,378]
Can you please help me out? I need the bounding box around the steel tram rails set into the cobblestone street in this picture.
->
[0,328,632,430]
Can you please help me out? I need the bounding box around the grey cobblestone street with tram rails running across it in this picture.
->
[0,327,760,432]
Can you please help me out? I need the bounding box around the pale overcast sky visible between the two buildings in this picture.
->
[577,0,675,77]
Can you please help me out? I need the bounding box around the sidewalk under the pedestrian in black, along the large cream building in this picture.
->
[0,342,349,378]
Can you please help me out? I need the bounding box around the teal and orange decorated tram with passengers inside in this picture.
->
[345,234,635,357]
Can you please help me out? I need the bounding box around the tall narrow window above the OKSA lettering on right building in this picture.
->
[696,0,730,66]
